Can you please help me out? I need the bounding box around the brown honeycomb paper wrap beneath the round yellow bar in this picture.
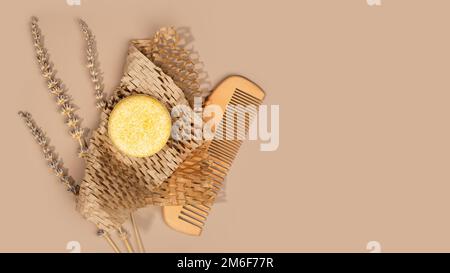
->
[77,28,216,232]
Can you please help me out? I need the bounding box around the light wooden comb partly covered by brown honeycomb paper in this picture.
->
[163,76,265,236]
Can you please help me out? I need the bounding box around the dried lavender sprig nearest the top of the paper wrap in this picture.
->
[79,19,106,109]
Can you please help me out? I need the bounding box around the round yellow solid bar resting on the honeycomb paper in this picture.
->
[108,95,172,157]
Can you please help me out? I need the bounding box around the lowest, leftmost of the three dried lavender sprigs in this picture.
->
[19,111,80,195]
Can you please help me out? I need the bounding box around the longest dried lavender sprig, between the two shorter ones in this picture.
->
[31,17,87,157]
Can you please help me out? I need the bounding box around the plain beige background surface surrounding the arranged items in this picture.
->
[0,0,450,252]
